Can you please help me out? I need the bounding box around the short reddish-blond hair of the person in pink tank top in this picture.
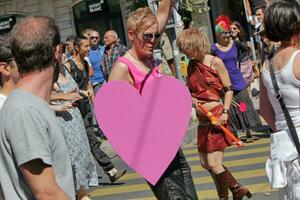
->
[127,7,158,33]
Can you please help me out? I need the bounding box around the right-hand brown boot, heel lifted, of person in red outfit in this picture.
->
[224,167,252,200]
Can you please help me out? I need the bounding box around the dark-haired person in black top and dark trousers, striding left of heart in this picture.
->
[65,36,126,183]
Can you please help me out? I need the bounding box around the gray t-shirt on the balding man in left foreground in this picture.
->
[0,89,75,200]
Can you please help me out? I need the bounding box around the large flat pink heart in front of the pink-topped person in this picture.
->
[95,77,192,185]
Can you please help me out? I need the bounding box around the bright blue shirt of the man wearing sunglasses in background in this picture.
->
[89,45,105,85]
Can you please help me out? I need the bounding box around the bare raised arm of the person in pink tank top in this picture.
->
[157,0,175,34]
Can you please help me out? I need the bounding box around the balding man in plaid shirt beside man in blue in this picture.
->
[102,30,127,78]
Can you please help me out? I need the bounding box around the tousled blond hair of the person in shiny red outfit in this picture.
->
[176,28,211,61]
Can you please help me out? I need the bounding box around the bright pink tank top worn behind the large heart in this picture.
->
[116,57,162,93]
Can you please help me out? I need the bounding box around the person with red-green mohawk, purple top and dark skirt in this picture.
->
[212,15,261,142]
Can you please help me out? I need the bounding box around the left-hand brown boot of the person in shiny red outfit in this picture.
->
[215,170,228,200]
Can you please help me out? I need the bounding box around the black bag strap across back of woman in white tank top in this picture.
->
[269,61,300,155]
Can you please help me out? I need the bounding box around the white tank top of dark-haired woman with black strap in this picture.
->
[262,50,300,130]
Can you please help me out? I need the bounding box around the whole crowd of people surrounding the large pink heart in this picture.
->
[0,0,300,200]
